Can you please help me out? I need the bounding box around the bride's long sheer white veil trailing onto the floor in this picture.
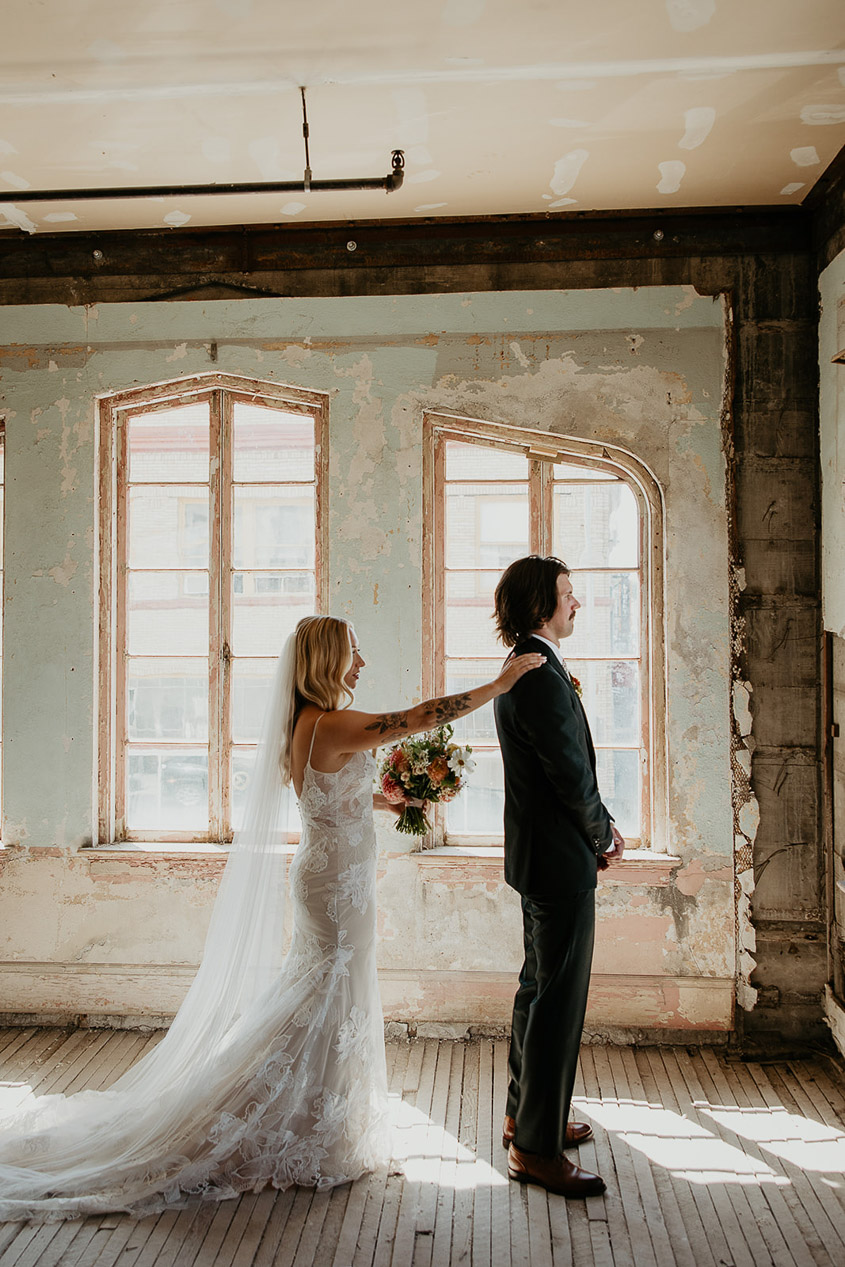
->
[0,635,295,1219]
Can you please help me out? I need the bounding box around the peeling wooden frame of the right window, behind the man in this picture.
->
[422,411,668,853]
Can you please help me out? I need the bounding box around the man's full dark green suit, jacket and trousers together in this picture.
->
[494,639,613,1157]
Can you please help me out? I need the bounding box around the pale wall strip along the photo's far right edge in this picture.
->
[818,251,845,1054]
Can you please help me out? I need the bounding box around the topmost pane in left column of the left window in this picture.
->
[127,403,209,484]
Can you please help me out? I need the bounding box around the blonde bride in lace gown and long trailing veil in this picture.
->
[0,616,542,1221]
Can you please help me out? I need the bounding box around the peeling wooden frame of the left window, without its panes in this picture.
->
[95,371,328,853]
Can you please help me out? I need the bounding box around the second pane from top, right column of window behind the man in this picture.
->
[552,481,640,568]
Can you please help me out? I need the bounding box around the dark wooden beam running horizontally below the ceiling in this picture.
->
[0,207,813,304]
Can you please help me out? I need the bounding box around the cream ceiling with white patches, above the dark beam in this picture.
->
[0,0,845,232]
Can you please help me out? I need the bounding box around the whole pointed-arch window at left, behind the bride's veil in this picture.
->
[99,375,327,841]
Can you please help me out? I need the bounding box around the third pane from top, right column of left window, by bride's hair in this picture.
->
[232,571,315,655]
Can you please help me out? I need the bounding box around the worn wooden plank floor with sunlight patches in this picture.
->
[0,1028,845,1267]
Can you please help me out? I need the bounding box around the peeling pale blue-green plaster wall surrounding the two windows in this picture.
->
[0,286,736,1034]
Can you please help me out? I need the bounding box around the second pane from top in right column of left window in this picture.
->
[234,484,314,568]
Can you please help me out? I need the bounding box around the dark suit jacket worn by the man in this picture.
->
[493,639,613,902]
